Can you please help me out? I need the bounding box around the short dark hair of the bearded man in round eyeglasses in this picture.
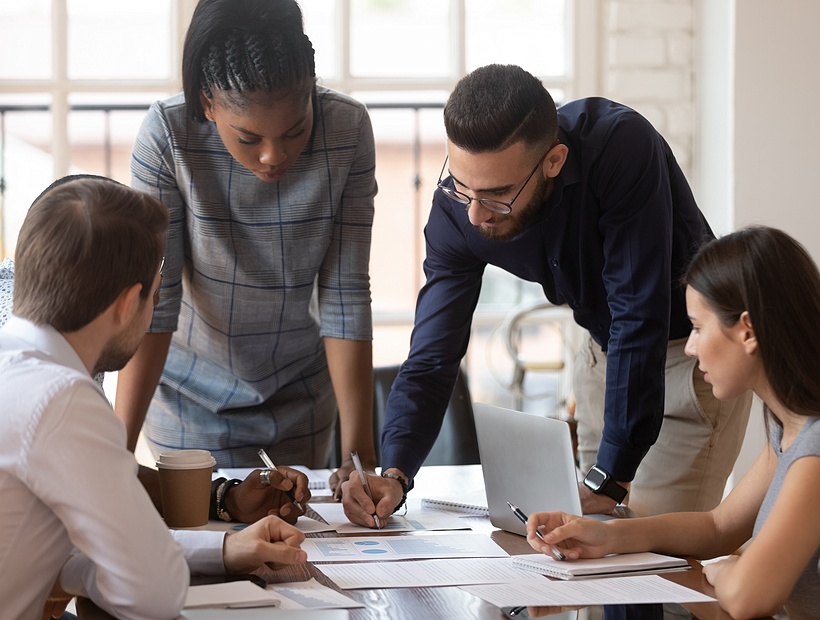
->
[444,65,558,153]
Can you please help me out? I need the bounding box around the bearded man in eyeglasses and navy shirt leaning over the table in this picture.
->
[344,65,751,526]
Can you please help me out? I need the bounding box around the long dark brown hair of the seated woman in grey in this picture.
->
[684,226,820,415]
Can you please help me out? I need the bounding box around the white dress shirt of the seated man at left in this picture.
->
[0,316,224,620]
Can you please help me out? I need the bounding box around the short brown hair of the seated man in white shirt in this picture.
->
[14,176,168,333]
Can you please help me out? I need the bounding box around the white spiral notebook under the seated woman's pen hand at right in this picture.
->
[513,552,691,579]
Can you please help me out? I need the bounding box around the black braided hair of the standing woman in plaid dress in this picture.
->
[182,0,316,121]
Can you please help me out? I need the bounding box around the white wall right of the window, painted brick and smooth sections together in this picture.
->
[596,0,820,480]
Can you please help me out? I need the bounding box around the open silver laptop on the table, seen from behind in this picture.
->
[473,403,581,535]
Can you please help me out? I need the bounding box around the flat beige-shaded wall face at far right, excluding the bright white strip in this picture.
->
[732,0,820,261]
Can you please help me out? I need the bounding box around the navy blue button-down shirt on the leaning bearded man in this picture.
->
[381,98,713,481]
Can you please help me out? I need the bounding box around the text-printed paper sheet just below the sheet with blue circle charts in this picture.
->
[317,558,532,590]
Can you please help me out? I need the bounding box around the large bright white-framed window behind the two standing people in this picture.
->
[0,0,589,414]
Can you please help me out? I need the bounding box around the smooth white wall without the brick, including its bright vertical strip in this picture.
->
[696,0,820,481]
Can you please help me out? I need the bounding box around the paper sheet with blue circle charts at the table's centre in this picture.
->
[302,533,509,562]
